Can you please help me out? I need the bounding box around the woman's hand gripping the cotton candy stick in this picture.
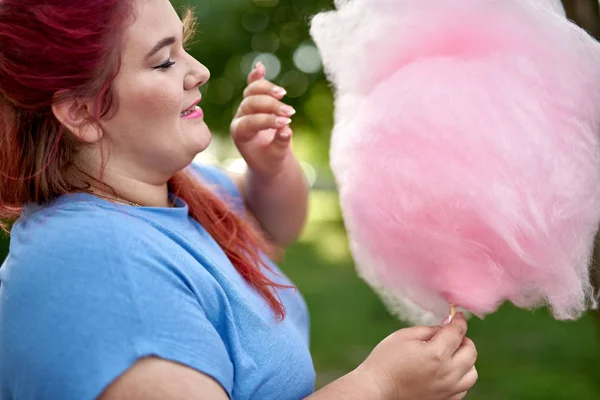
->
[354,313,478,400]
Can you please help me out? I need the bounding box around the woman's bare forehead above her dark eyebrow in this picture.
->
[124,0,181,55]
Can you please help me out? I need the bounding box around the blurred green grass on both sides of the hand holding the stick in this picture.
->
[281,192,600,400]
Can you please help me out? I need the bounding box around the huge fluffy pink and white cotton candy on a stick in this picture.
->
[311,0,600,323]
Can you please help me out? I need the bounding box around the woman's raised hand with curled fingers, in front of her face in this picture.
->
[230,62,296,178]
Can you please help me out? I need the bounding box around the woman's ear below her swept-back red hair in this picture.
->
[52,99,103,144]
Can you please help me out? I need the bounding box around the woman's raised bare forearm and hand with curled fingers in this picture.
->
[231,63,308,247]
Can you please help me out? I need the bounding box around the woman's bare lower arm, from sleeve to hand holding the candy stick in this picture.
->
[99,314,478,400]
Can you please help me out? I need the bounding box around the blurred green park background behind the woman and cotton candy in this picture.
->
[0,0,600,400]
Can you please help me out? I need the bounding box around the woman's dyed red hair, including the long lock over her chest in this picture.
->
[0,0,290,319]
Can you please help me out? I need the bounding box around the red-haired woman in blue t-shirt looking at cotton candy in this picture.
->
[0,0,477,400]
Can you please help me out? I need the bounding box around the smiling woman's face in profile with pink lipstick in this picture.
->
[97,0,211,184]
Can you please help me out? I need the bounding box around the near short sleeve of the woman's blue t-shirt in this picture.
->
[0,211,233,400]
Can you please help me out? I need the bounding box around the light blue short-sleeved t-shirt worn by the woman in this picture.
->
[0,163,315,400]
